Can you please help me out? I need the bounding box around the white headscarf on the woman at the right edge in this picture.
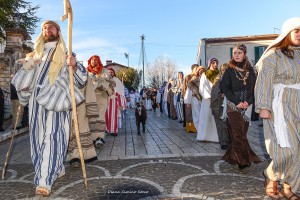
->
[256,17,300,66]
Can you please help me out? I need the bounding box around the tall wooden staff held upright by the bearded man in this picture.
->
[61,0,88,189]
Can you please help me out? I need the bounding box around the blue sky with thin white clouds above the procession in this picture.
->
[27,0,300,74]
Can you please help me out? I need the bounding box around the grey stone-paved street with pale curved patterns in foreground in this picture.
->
[0,110,292,200]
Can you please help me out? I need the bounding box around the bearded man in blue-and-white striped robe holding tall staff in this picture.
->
[12,20,87,196]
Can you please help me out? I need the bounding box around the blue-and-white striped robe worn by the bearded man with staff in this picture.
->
[12,42,87,191]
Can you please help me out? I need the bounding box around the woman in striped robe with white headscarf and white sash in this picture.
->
[255,17,300,200]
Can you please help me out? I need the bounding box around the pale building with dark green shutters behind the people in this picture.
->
[196,34,278,67]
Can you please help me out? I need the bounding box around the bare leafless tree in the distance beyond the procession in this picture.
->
[146,56,177,88]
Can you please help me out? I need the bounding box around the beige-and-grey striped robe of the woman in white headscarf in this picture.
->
[254,47,300,193]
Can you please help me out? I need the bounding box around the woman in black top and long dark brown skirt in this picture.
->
[220,44,260,169]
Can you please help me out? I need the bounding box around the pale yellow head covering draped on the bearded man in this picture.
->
[34,20,66,85]
